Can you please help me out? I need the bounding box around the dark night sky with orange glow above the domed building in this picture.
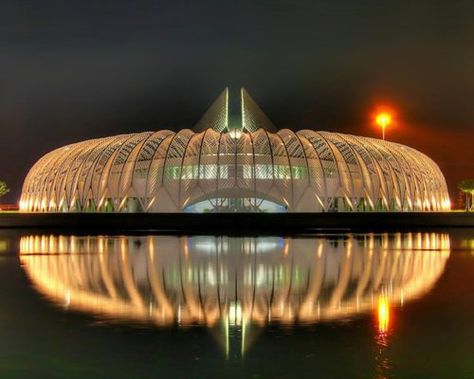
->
[0,0,474,202]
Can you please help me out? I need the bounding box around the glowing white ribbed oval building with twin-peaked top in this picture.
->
[20,89,450,212]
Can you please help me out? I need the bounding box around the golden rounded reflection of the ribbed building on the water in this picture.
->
[20,233,449,328]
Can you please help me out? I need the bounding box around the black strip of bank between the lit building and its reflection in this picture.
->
[0,212,474,235]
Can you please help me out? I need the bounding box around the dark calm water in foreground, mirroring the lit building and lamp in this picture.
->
[0,229,474,379]
